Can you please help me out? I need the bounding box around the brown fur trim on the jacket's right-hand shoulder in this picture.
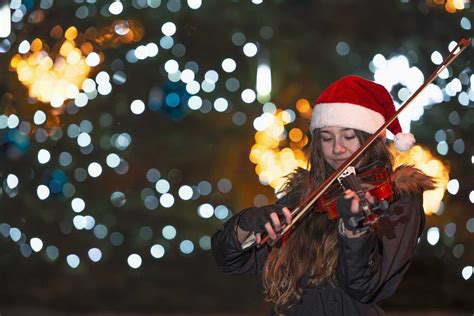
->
[391,165,436,195]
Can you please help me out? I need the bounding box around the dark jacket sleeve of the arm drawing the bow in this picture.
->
[211,210,270,274]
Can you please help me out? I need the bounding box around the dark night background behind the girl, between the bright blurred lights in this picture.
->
[0,0,474,315]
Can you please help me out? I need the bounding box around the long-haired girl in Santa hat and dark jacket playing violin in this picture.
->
[212,76,434,315]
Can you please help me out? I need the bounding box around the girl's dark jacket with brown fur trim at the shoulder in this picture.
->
[212,167,433,316]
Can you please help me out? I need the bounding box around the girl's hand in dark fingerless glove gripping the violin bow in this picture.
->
[237,204,292,244]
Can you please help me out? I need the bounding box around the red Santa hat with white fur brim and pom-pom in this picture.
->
[310,75,415,151]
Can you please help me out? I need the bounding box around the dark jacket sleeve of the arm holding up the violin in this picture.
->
[336,193,425,303]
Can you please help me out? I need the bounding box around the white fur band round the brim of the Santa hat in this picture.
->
[310,103,385,134]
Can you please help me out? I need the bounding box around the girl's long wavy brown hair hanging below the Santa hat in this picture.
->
[262,129,393,314]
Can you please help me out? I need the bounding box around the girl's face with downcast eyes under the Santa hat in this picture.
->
[320,127,361,170]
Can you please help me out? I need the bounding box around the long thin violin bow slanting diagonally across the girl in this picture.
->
[242,38,471,249]
